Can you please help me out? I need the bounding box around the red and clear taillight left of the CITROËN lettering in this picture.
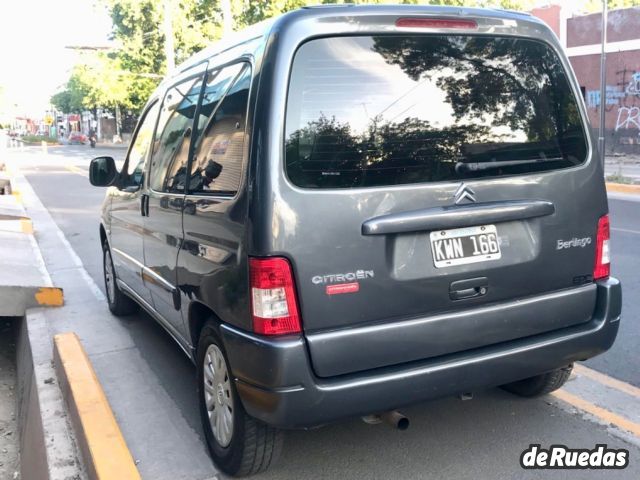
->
[249,257,300,335]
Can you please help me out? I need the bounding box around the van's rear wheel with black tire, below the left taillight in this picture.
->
[197,322,283,477]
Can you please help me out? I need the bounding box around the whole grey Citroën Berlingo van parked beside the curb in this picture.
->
[90,6,621,475]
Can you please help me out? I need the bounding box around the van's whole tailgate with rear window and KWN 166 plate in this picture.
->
[282,34,606,376]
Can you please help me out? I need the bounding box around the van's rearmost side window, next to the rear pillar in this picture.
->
[189,64,251,195]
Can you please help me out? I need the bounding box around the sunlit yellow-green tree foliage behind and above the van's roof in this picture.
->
[51,0,536,113]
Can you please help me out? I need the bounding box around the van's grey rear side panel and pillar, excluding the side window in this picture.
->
[176,55,263,334]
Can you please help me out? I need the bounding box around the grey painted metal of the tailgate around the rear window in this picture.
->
[249,7,608,376]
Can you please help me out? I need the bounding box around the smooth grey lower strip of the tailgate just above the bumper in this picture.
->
[307,284,596,377]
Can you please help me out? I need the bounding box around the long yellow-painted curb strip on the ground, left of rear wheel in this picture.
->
[53,333,141,480]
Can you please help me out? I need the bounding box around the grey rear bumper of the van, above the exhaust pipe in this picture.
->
[221,278,622,428]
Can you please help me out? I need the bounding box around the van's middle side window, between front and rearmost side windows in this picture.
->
[149,74,204,193]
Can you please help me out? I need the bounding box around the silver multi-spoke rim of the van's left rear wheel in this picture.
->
[203,344,234,447]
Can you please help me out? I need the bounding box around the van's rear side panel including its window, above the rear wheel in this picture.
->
[178,62,251,330]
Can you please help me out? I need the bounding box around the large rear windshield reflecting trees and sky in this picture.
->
[285,35,586,188]
